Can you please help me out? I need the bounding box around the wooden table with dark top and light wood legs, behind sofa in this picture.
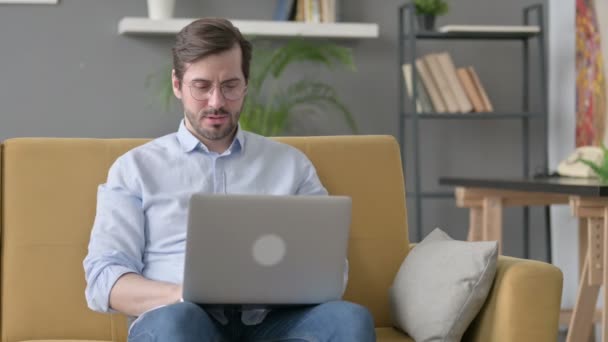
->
[439,177,608,342]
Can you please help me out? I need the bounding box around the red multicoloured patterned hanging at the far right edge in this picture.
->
[576,0,606,147]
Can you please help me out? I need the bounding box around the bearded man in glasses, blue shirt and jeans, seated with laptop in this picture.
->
[84,18,375,341]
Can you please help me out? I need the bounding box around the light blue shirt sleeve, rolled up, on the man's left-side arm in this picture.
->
[83,158,145,312]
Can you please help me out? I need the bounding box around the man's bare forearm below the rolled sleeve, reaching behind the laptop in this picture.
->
[110,273,182,316]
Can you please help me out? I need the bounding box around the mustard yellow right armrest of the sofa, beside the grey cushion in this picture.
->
[463,256,563,342]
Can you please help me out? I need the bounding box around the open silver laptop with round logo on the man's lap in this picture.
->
[183,194,351,305]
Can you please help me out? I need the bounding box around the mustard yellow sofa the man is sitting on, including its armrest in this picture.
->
[0,136,562,342]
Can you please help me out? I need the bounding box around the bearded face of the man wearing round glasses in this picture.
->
[172,45,246,144]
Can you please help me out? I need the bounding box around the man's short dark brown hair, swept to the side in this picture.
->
[171,18,252,84]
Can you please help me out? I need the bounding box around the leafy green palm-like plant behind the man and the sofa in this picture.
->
[146,39,358,136]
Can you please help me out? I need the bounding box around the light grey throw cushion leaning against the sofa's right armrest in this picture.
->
[390,229,498,342]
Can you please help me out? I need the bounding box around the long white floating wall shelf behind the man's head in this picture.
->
[118,17,379,39]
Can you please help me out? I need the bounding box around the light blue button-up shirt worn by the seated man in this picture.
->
[84,120,327,324]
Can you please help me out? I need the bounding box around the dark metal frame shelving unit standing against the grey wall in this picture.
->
[398,2,551,257]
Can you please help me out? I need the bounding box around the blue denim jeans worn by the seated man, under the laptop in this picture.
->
[129,301,376,342]
